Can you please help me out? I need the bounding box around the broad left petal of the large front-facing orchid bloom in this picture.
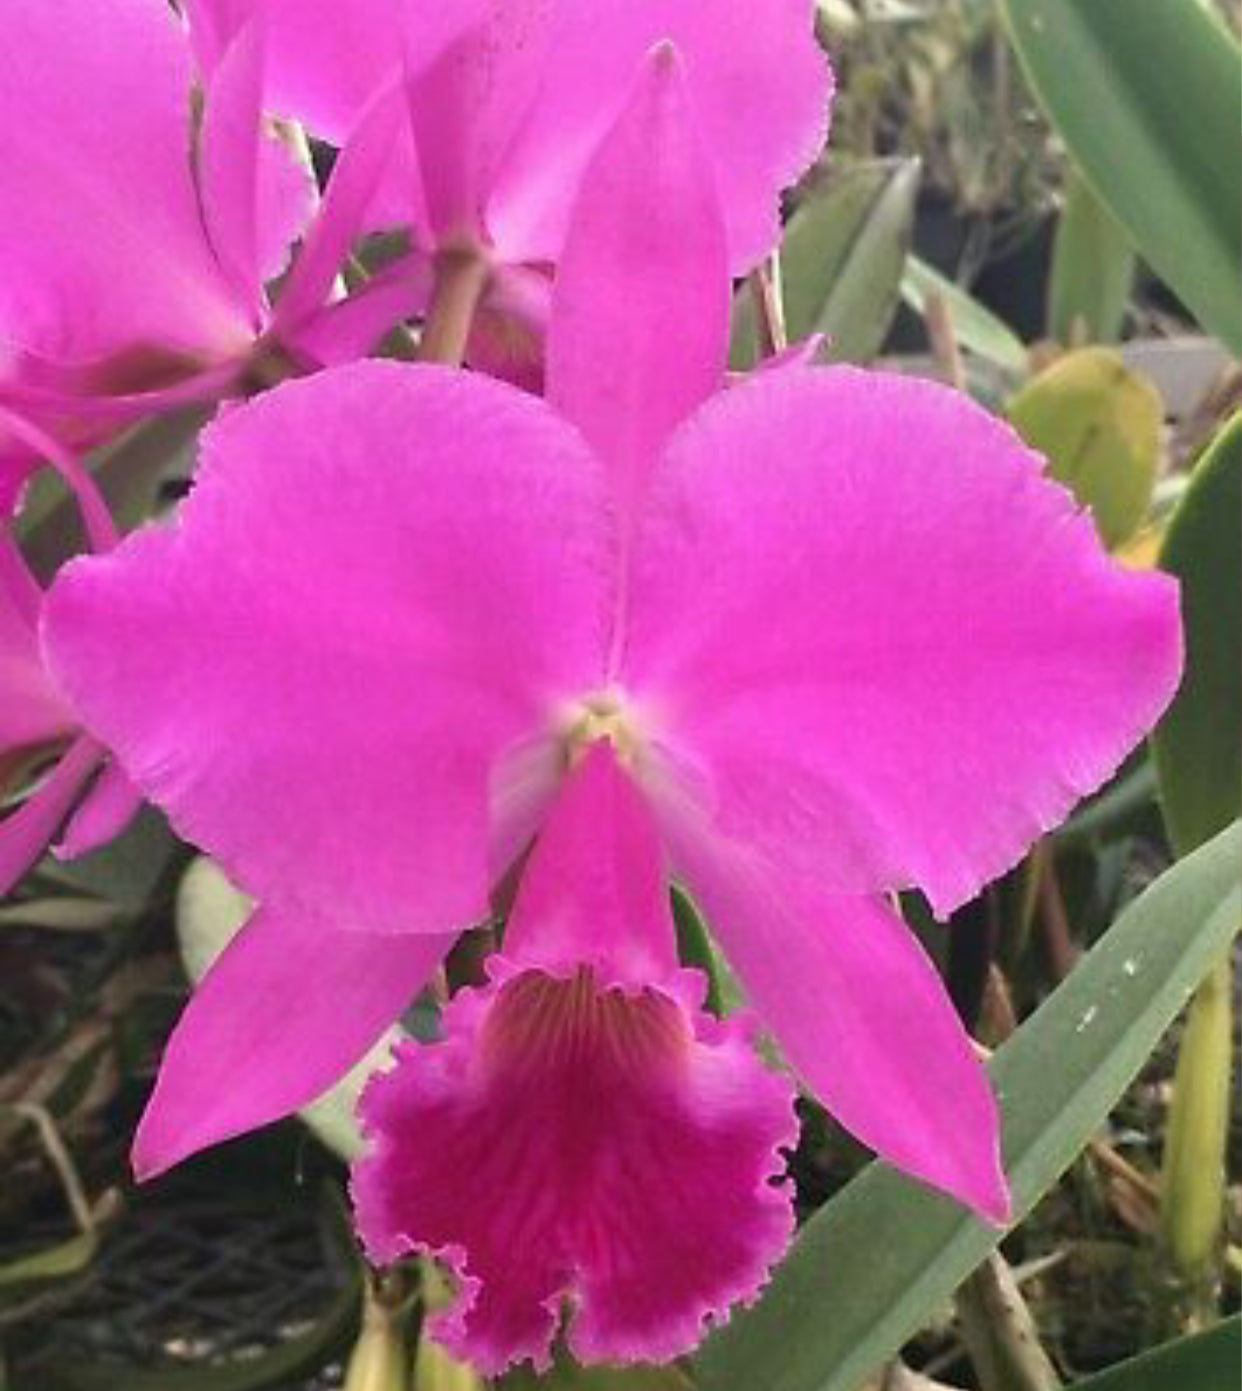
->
[45,363,613,932]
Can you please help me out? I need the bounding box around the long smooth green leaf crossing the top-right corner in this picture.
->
[1001,0,1242,353]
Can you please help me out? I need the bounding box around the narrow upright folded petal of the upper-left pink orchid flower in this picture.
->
[197,14,314,318]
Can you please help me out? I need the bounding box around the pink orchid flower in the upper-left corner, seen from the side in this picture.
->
[0,0,395,512]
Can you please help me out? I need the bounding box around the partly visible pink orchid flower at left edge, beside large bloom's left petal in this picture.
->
[0,408,142,894]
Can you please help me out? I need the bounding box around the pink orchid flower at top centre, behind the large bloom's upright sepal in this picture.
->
[179,0,833,372]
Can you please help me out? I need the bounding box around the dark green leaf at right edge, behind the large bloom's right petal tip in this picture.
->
[1152,416,1242,851]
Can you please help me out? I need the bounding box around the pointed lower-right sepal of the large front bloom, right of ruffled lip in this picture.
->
[665,812,1008,1225]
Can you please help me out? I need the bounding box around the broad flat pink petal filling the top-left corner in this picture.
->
[0,0,249,362]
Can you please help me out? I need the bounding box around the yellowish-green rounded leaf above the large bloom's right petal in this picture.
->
[1007,348,1164,549]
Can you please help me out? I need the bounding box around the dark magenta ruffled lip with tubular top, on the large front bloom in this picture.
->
[353,744,797,1374]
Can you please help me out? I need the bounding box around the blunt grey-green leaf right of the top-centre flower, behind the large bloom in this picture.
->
[733,159,921,367]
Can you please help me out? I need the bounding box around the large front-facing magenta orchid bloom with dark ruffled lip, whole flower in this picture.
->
[45,46,1181,1367]
